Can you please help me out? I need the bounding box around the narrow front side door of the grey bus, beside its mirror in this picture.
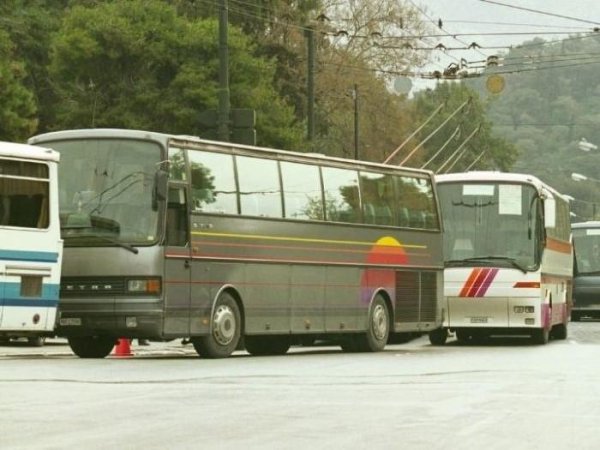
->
[164,183,191,336]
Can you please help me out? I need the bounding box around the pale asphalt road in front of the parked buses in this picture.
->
[0,322,600,450]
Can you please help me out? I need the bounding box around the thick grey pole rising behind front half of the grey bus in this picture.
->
[217,0,230,142]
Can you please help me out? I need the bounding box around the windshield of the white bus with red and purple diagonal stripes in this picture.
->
[438,183,542,272]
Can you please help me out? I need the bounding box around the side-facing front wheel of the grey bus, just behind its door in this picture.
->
[191,292,242,358]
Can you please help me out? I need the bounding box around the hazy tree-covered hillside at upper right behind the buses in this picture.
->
[473,34,600,217]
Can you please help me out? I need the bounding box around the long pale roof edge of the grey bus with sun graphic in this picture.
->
[28,128,433,176]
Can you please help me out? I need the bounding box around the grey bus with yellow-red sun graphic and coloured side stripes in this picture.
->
[30,129,443,358]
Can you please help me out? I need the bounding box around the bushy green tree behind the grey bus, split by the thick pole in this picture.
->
[50,0,302,148]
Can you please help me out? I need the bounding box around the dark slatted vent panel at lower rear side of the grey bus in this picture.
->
[394,271,437,323]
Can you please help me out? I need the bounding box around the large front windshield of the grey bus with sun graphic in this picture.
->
[52,139,161,248]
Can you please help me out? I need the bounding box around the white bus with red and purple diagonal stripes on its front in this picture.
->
[429,172,573,345]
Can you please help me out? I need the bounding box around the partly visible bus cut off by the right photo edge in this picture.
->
[571,221,600,322]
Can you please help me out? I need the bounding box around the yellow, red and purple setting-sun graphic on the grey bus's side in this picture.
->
[360,236,408,303]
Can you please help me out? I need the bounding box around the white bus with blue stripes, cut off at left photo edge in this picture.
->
[0,142,62,345]
